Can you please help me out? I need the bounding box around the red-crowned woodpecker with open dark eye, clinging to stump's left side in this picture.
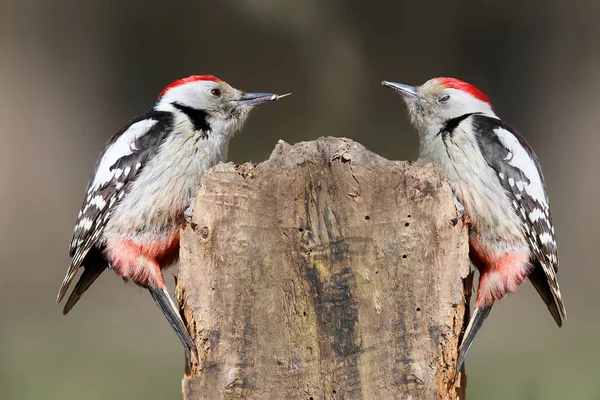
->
[56,75,287,364]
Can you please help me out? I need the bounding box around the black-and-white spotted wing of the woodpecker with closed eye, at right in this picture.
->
[473,115,566,326]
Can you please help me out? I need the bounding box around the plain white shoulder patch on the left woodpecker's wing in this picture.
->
[90,119,158,192]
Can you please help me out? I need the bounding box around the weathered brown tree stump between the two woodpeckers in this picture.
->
[177,138,469,400]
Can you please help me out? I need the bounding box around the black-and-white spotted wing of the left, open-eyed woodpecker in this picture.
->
[57,110,173,302]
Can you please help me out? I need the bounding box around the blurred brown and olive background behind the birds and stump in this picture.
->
[0,0,600,400]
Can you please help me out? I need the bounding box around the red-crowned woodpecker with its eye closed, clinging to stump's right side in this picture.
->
[382,78,566,374]
